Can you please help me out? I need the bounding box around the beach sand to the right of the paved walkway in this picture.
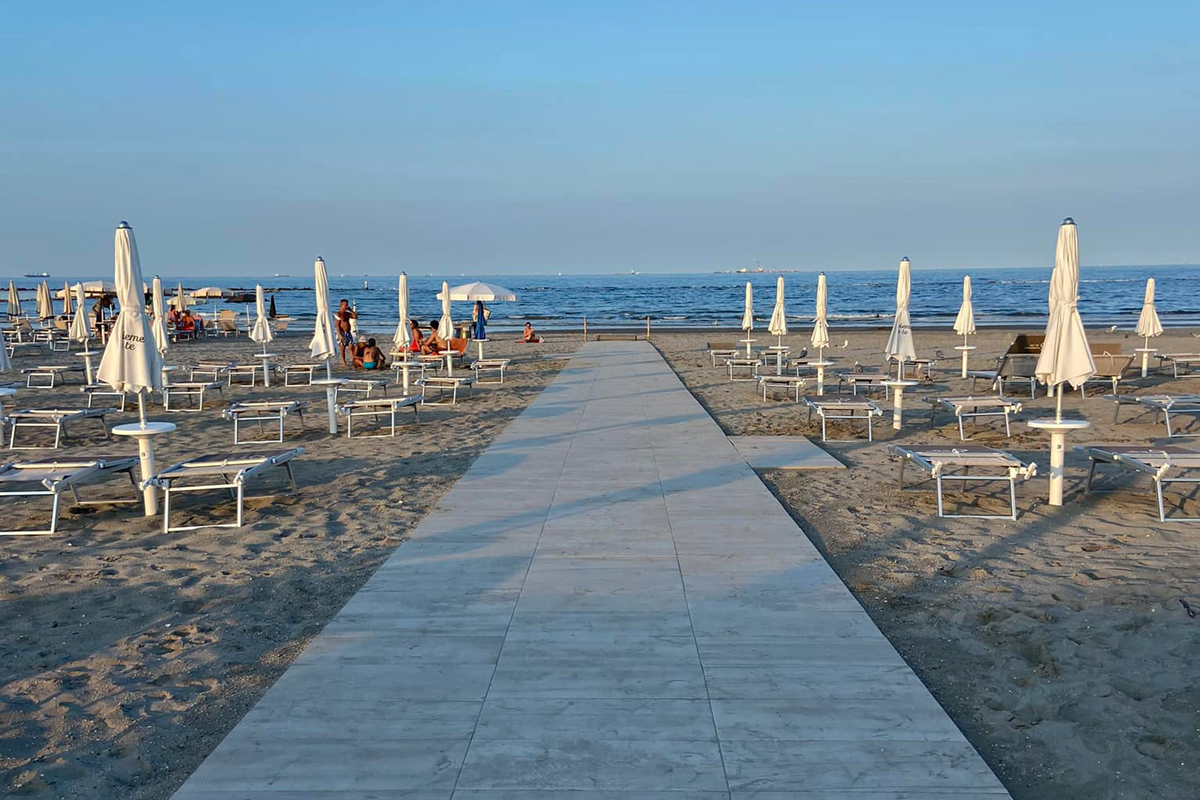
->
[653,329,1200,800]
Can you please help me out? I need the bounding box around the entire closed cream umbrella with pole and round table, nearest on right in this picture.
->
[1028,217,1096,506]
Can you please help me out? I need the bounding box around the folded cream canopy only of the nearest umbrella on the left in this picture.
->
[96,222,162,395]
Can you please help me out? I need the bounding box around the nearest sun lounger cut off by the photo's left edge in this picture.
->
[0,456,142,536]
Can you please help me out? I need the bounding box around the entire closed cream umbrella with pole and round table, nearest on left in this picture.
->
[96,222,175,517]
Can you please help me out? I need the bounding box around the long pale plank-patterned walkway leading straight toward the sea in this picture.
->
[175,342,1008,800]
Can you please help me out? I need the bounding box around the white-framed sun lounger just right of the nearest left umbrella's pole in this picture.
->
[146,447,304,533]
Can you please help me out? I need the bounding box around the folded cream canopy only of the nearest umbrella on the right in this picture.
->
[1034,217,1096,387]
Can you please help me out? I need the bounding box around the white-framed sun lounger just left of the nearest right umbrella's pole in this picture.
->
[888,445,1038,519]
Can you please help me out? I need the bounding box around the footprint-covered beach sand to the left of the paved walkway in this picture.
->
[0,332,582,799]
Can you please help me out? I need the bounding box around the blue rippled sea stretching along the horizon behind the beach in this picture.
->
[17,265,1200,335]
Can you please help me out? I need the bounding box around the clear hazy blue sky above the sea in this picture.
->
[0,0,1200,276]
